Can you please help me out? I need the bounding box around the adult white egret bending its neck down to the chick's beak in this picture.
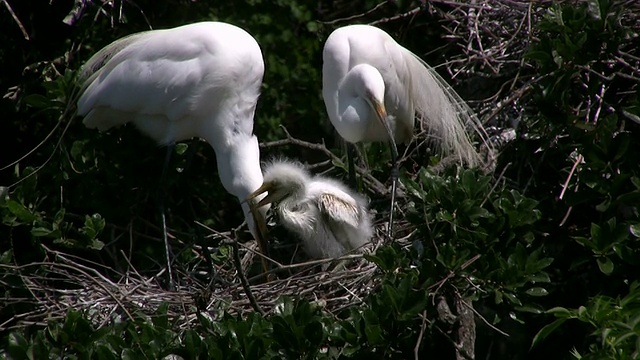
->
[77,22,266,283]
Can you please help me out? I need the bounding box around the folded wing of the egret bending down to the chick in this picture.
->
[78,30,208,119]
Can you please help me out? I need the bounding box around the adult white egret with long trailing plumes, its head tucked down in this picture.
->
[322,25,490,235]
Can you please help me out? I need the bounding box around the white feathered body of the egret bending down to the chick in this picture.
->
[78,22,264,126]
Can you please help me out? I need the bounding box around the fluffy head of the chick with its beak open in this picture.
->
[247,160,311,207]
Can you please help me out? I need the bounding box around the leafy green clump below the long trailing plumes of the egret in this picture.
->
[404,169,553,317]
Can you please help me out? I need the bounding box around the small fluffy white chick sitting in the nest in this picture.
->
[248,160,373,259]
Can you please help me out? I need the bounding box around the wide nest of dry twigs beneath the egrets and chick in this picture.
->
[0,225,398,330]
